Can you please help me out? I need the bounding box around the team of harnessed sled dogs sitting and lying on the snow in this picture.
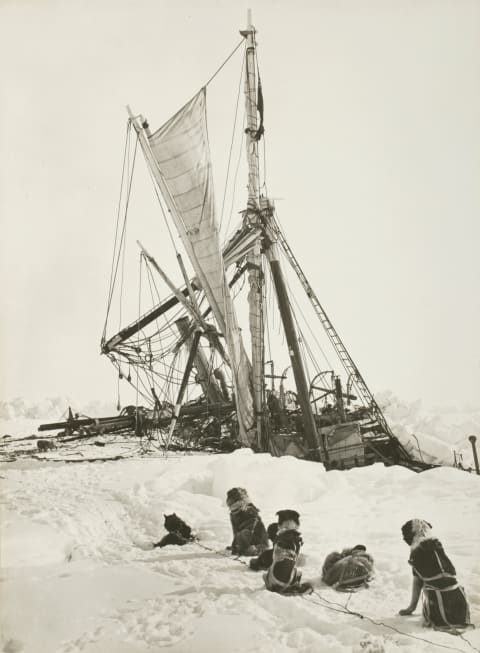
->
[154,487,473,634]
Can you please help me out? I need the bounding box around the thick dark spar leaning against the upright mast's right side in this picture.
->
[267,243,327,462]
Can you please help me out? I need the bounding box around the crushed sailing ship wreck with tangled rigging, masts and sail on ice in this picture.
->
[41,18,428,469]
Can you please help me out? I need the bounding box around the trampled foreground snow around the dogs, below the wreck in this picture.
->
[0,411,480,653]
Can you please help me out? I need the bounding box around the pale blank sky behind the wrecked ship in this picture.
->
[0,0,480,407]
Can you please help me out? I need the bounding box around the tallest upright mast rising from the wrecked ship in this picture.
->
[241,9,265,449]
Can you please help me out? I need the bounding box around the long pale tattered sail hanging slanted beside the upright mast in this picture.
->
[148,88,255,444]
